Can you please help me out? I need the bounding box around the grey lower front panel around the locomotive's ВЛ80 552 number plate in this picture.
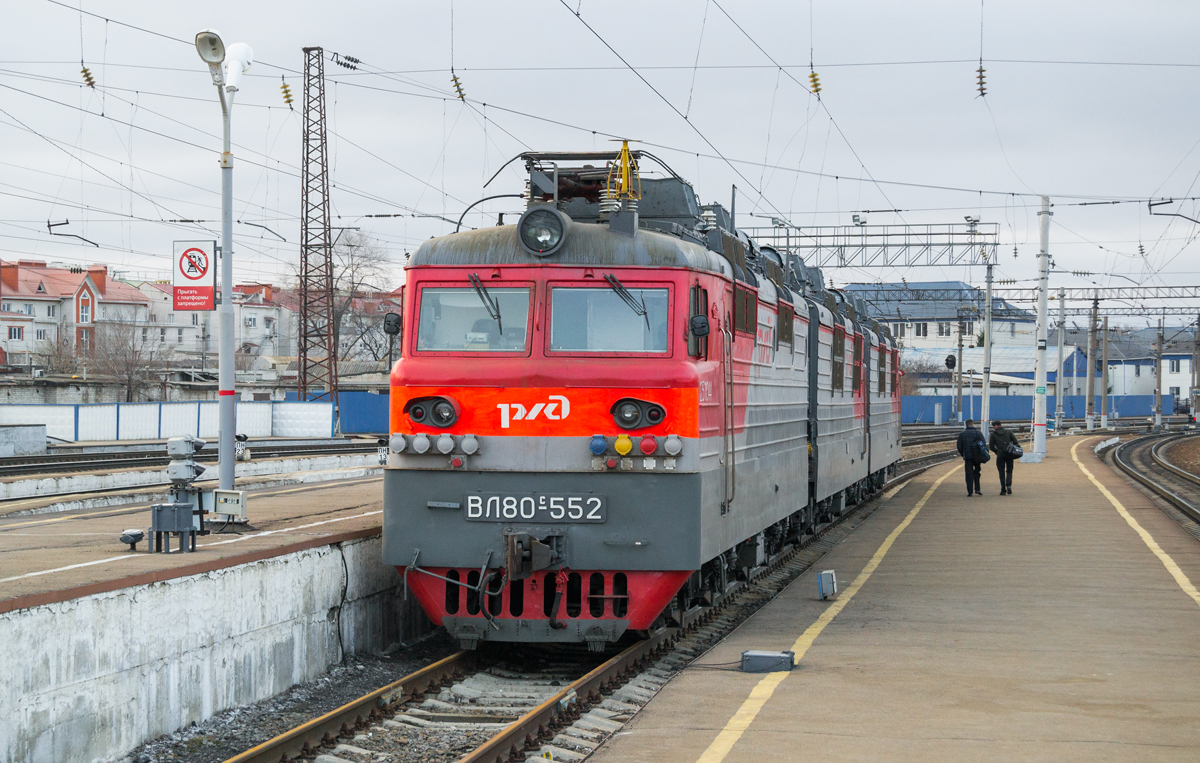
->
[383,469,706,570]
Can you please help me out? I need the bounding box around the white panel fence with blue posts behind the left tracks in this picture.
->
[0,402,334,443]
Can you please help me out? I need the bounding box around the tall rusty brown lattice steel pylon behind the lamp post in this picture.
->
[296,48,337,411]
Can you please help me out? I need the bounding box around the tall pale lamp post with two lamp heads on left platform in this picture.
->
[196,29,254,491]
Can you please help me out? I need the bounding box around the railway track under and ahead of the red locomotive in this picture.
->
[218,451,958,763]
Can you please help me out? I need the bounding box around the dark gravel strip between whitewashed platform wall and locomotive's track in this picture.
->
[121,630,458,763]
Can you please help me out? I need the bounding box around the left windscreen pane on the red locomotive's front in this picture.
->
[416,287,529,353]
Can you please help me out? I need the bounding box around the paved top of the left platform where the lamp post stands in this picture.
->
[0,474,383,613]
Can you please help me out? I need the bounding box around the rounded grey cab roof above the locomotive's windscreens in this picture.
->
[409,222,733,278]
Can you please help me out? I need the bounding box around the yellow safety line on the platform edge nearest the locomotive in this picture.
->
[696,464,962,763]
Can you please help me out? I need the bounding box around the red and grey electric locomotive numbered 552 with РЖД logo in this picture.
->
[384,148,900,649]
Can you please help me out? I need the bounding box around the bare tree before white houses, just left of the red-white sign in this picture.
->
[88,311,175,403]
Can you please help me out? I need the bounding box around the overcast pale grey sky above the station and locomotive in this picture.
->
[0,0,1200,323]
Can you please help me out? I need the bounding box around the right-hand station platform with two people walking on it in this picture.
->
[590,437,1200,763]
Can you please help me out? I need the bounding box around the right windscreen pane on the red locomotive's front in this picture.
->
[550,287,671,353]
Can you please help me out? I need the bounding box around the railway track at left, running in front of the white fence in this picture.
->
[0,443,378,477]
